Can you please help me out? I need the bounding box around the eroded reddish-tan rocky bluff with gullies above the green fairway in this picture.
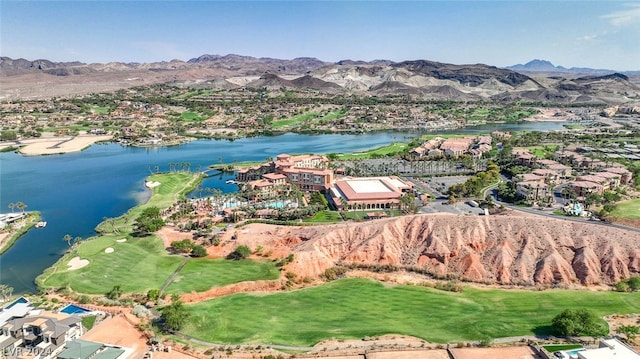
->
[253,215,640,285]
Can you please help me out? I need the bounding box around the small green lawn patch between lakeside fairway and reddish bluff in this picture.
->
[167,258,280,294]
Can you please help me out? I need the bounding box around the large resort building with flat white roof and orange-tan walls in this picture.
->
[328,176,413,210]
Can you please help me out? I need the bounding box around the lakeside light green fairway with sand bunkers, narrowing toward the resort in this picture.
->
[36,172,200,294]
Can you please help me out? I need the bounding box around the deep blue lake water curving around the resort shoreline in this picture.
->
[0,123,562,294]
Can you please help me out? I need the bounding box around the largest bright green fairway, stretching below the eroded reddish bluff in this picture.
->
[182,279,640,345]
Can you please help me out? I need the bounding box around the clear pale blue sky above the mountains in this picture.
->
[0,0,640,70]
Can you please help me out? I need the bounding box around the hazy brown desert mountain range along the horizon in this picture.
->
[0,54,640,103]
